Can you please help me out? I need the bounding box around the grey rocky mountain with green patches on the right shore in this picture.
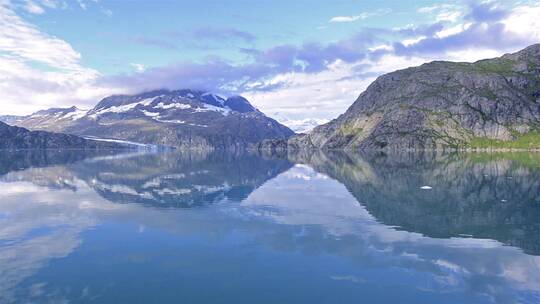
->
[260,44,540,150]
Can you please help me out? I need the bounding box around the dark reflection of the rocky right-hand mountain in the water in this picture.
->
[291,152,540,255]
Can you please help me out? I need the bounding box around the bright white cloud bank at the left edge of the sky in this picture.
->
[0,1,116,114]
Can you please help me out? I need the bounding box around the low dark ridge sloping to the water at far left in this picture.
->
[0,122,126,150]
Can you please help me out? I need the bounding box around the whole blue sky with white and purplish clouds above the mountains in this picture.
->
[0,0,540,125]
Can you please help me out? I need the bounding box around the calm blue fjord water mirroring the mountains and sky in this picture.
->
[0,151,540,303]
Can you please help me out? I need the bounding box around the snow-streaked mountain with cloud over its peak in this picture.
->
[2,90,294,149]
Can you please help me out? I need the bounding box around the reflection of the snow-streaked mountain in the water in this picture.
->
[3,152,292,208]
